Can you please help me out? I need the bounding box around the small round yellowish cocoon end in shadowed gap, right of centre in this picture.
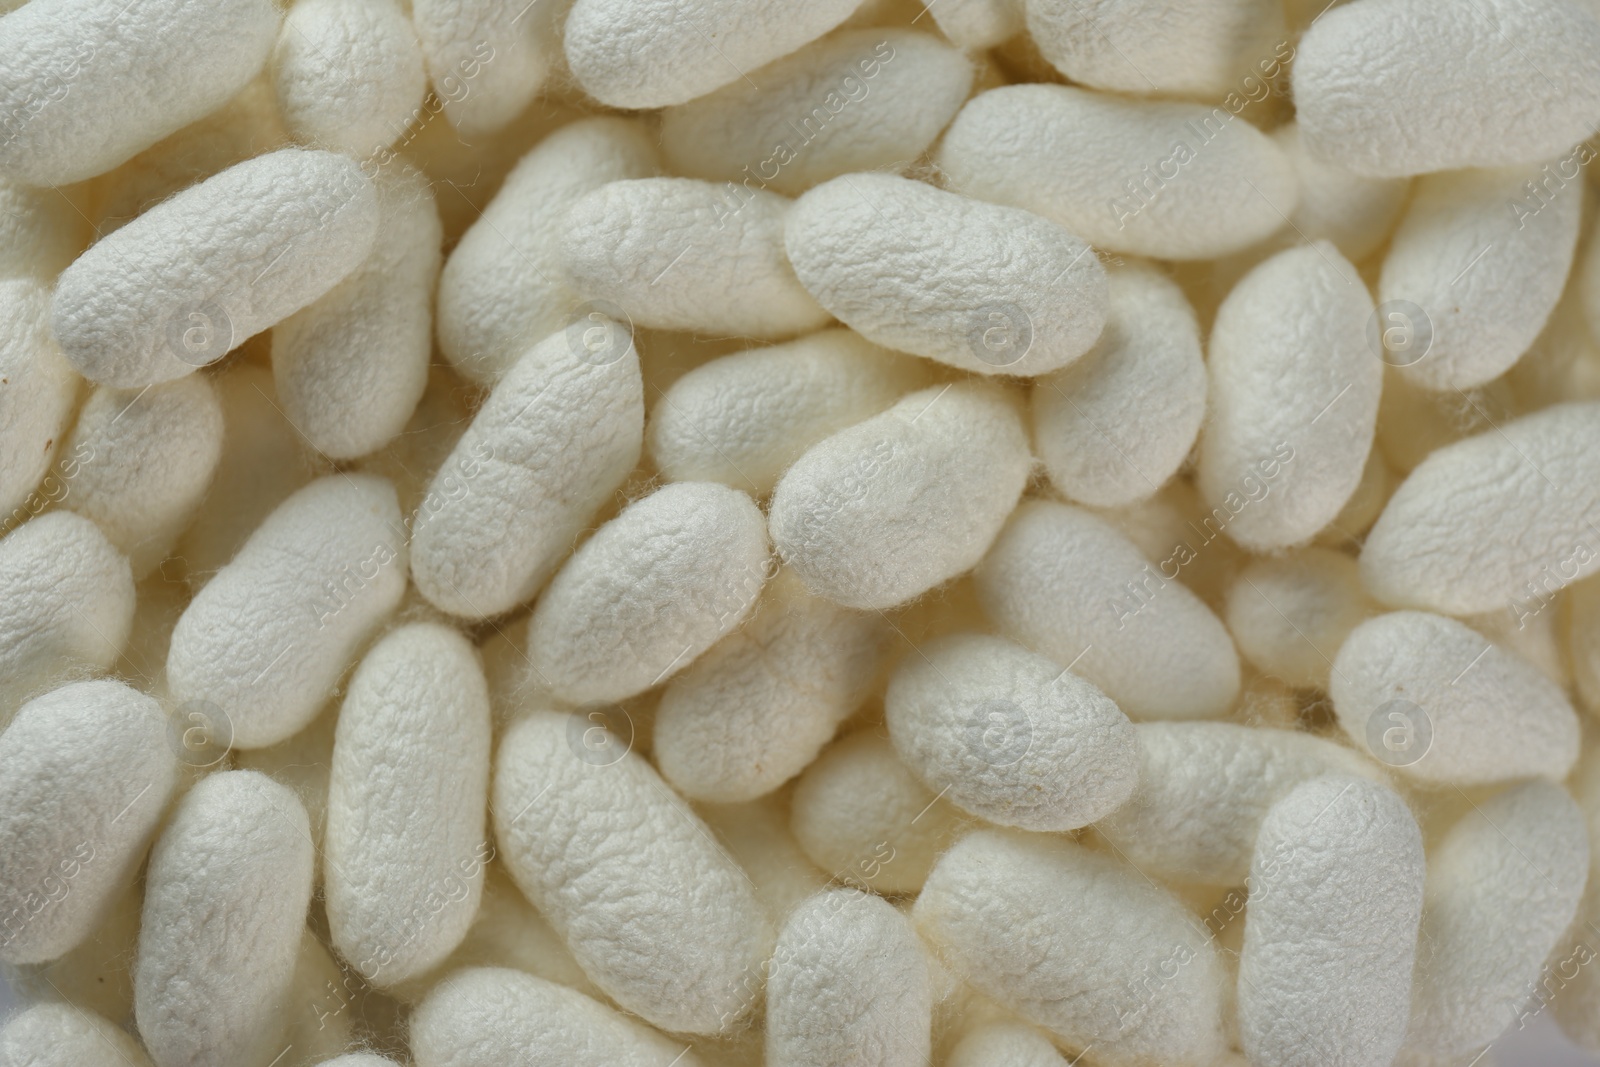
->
[1227,547,1374,689]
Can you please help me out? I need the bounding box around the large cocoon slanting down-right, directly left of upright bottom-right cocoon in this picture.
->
[912,830,1226,1067]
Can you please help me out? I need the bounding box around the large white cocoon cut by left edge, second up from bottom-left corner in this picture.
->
[0,681,178,963]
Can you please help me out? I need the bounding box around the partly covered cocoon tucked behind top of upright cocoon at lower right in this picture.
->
[1094,723,1378,885]
